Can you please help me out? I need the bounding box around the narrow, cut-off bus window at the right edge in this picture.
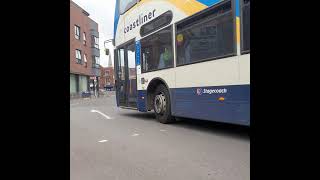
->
[241,0,250,54]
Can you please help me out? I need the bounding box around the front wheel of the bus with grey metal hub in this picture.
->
[153,84,174,124]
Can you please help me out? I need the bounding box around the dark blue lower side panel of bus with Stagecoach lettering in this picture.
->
[171,84,250,126]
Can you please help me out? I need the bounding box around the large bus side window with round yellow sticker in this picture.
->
[176,0,236,66]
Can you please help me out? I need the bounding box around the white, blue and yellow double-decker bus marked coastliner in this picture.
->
[114,0,250,126]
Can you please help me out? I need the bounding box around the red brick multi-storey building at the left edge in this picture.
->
[70,1,100,97]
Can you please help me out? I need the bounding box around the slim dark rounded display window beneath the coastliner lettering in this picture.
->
[140,11,172,36]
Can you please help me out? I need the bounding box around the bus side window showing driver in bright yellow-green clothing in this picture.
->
[141,26,173,72]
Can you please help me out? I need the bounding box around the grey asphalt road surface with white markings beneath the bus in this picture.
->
[70,92,250,180]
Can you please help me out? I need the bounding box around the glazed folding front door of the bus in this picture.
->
[116,41,137,108]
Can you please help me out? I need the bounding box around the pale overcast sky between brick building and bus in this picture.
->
[72,0,116,67]
